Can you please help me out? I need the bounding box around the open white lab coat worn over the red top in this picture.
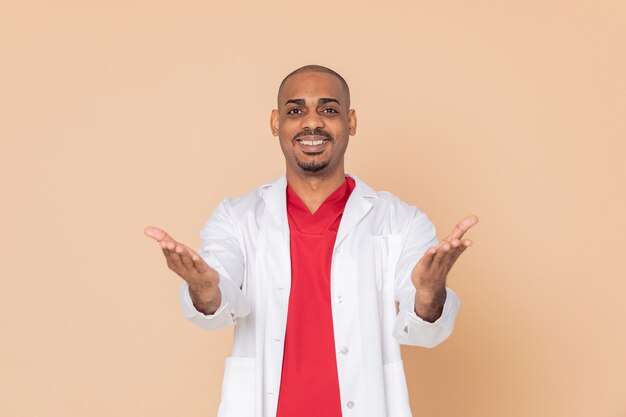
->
[179,175,459,417]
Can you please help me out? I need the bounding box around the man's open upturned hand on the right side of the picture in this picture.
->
[411,216,478,322]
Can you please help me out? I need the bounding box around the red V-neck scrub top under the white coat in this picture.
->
[277,177,355,417]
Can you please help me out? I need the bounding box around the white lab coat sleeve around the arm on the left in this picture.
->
[179,200,250,330]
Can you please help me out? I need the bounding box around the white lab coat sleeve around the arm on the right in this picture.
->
[393,209,460,348]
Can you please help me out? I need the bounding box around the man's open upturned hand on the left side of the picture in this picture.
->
[143,226,222,314]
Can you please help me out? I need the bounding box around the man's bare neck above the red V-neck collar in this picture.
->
[287,169,346,213]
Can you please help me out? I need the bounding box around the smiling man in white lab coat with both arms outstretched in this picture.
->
[145,65,478,417]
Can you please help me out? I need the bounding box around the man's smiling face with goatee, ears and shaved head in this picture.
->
[270,72,356,176]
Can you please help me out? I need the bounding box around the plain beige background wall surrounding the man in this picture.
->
[0,0,626,417]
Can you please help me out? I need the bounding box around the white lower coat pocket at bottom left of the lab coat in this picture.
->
[217,356,256,417]
